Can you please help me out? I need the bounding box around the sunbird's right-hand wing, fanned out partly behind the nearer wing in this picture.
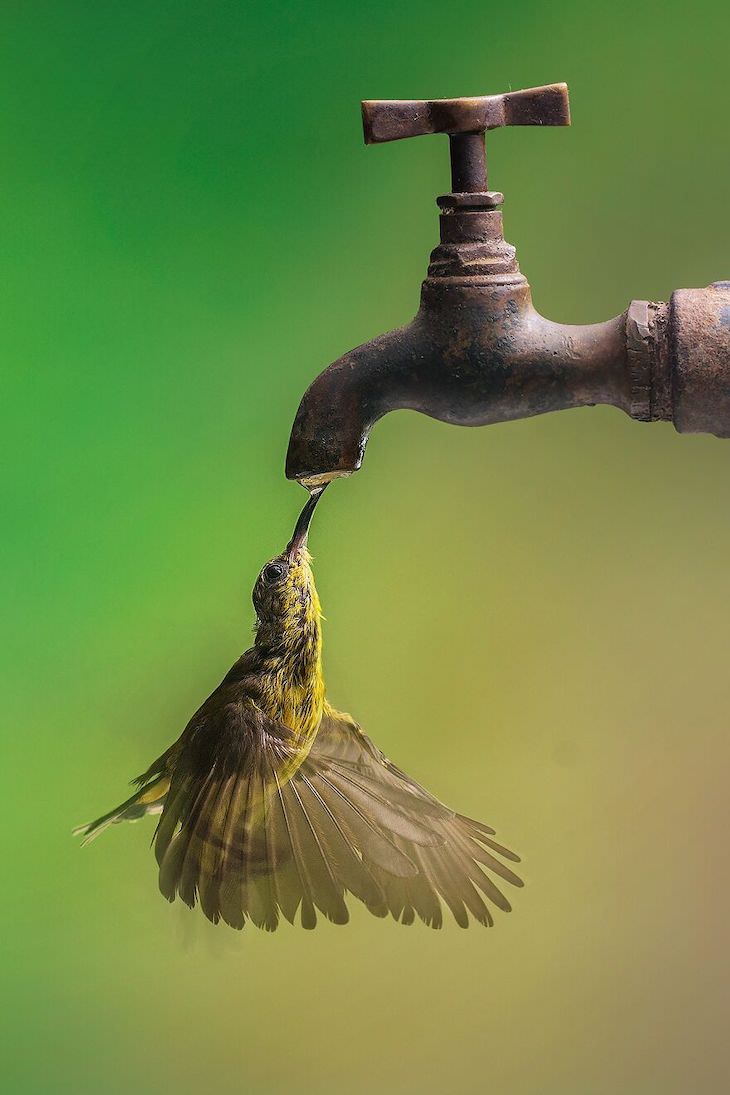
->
[308,708,522,927]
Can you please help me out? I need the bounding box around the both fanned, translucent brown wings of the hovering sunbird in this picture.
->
[154,700,520,931]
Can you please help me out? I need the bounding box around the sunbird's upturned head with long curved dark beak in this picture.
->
[253,491,322,643]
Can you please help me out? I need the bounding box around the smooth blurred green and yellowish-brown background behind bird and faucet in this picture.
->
[0,0,730,1095]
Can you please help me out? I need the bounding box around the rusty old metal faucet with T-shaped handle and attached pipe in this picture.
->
[287,83,730,488]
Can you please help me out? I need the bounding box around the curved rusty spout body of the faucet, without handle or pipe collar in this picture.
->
[287,275,630,486]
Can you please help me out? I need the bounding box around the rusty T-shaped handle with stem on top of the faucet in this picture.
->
[362,83,570,194]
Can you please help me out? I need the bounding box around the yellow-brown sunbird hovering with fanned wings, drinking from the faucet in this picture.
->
[74,491,522,931]
